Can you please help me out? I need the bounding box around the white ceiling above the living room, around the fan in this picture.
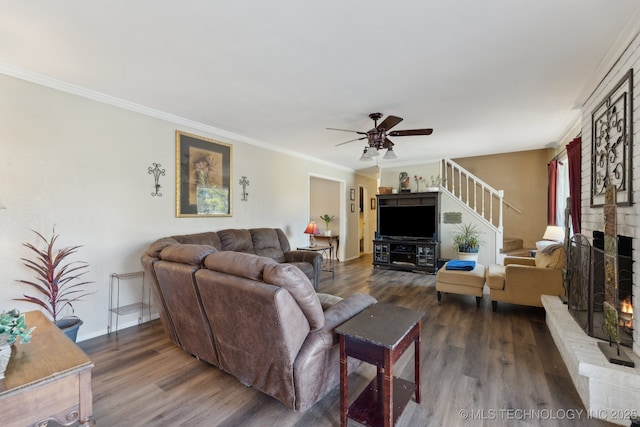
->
[0,0,640,173]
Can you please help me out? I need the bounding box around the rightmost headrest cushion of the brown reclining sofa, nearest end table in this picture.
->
[263,263,324,331]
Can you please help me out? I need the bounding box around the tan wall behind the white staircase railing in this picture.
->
[453,149,553,248]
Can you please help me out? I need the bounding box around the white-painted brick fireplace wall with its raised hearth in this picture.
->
[542,30,640,426]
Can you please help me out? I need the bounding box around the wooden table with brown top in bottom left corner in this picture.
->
[0,311,95,427]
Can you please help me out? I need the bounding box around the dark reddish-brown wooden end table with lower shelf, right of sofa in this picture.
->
[336,303,424,427]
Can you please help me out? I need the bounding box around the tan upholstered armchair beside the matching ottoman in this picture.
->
[486,245,566,311]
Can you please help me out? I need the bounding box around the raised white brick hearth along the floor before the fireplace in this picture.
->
[542,295,640,426]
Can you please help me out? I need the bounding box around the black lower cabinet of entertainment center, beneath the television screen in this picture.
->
[373,238,440,274]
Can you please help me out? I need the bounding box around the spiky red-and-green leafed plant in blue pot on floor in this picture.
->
[15,227,92,342]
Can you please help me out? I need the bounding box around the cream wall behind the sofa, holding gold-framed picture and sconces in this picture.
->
[0,75,376,340]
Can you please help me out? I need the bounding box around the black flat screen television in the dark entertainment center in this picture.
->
[378,205,438,240]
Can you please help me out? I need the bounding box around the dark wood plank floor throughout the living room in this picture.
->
[79,256,612,427]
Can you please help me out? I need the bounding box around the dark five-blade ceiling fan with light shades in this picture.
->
[327,113,433,160]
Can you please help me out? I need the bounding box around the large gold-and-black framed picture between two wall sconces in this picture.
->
[176,131,232,217]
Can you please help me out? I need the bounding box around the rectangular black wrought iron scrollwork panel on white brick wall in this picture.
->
[591,69,633,207]
